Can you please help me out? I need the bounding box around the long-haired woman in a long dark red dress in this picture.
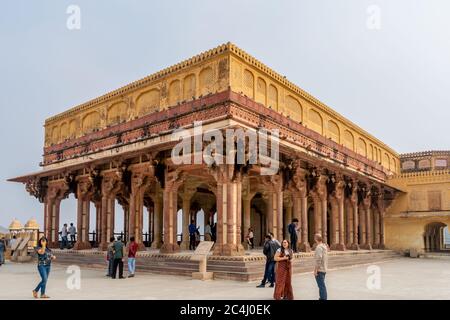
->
[273,240,294,300]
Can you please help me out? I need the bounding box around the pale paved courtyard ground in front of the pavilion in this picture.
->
[0,258,450,300]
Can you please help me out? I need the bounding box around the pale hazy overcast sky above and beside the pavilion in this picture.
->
[0,0,450,230]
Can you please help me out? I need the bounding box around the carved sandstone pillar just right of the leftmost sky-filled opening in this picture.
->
[74,176,95,250]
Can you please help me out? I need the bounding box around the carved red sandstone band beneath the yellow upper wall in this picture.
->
[7,91,394,181]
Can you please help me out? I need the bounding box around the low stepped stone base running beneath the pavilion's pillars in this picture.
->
[54,250,400,281]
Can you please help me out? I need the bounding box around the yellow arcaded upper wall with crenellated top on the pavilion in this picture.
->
[45,43,400,173]
